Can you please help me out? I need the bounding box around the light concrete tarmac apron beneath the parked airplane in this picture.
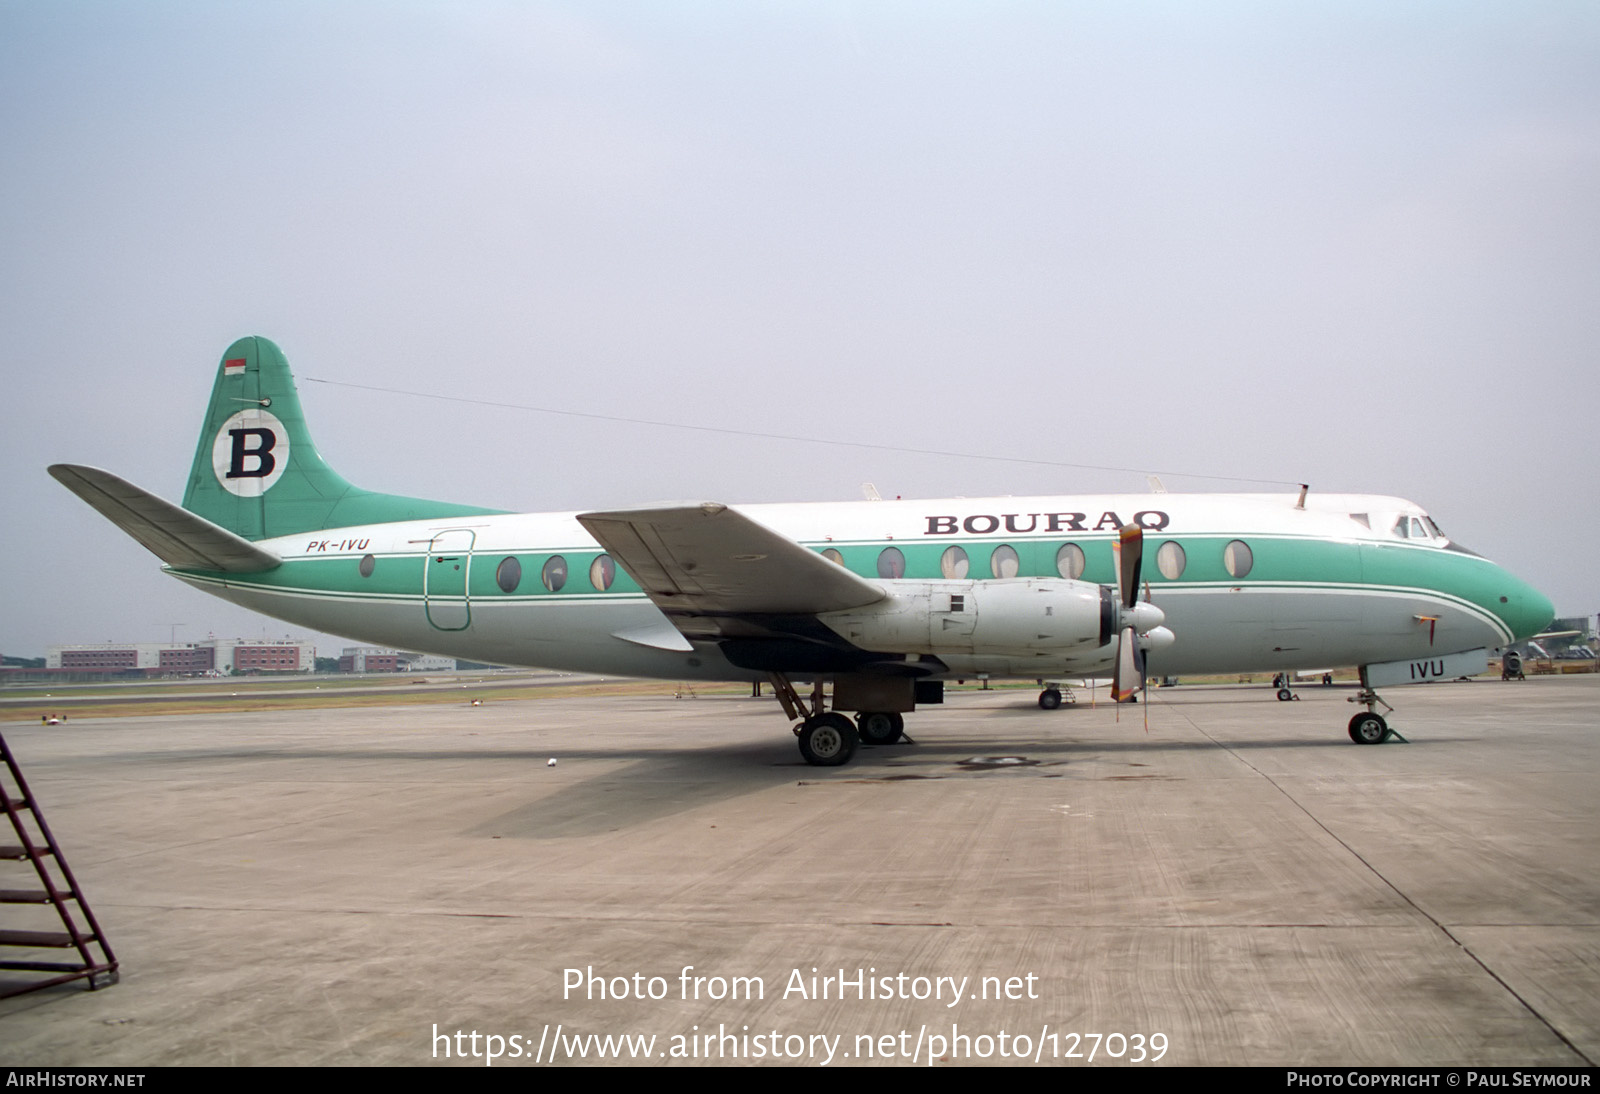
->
[0,677,1600,1067]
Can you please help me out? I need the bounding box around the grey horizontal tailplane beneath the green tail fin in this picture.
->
[50,464,283,574]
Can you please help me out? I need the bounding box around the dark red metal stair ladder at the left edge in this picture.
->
[0,736,117,998]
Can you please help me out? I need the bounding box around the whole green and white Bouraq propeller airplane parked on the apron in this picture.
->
[50,337,1555,766]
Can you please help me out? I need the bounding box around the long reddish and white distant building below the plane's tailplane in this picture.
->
[45,638,317,677]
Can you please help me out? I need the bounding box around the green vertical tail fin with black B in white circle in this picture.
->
[184,337,502,539]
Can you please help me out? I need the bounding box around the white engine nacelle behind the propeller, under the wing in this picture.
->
[818,577,1118,656]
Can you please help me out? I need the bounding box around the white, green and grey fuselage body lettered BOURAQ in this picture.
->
[171,494,1549,680]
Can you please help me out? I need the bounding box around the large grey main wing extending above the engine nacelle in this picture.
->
[578,502,885,638]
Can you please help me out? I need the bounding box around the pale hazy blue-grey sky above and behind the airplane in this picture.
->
[0,0,1600,656]
